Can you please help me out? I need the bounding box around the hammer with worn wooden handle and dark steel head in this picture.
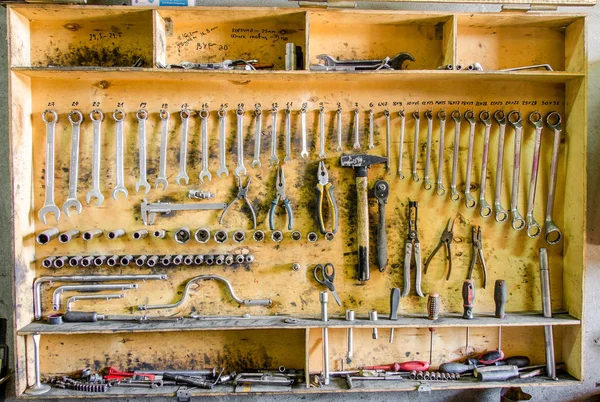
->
[340,154,387,281]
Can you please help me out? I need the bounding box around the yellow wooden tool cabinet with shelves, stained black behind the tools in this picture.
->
[8,5,587,398]
